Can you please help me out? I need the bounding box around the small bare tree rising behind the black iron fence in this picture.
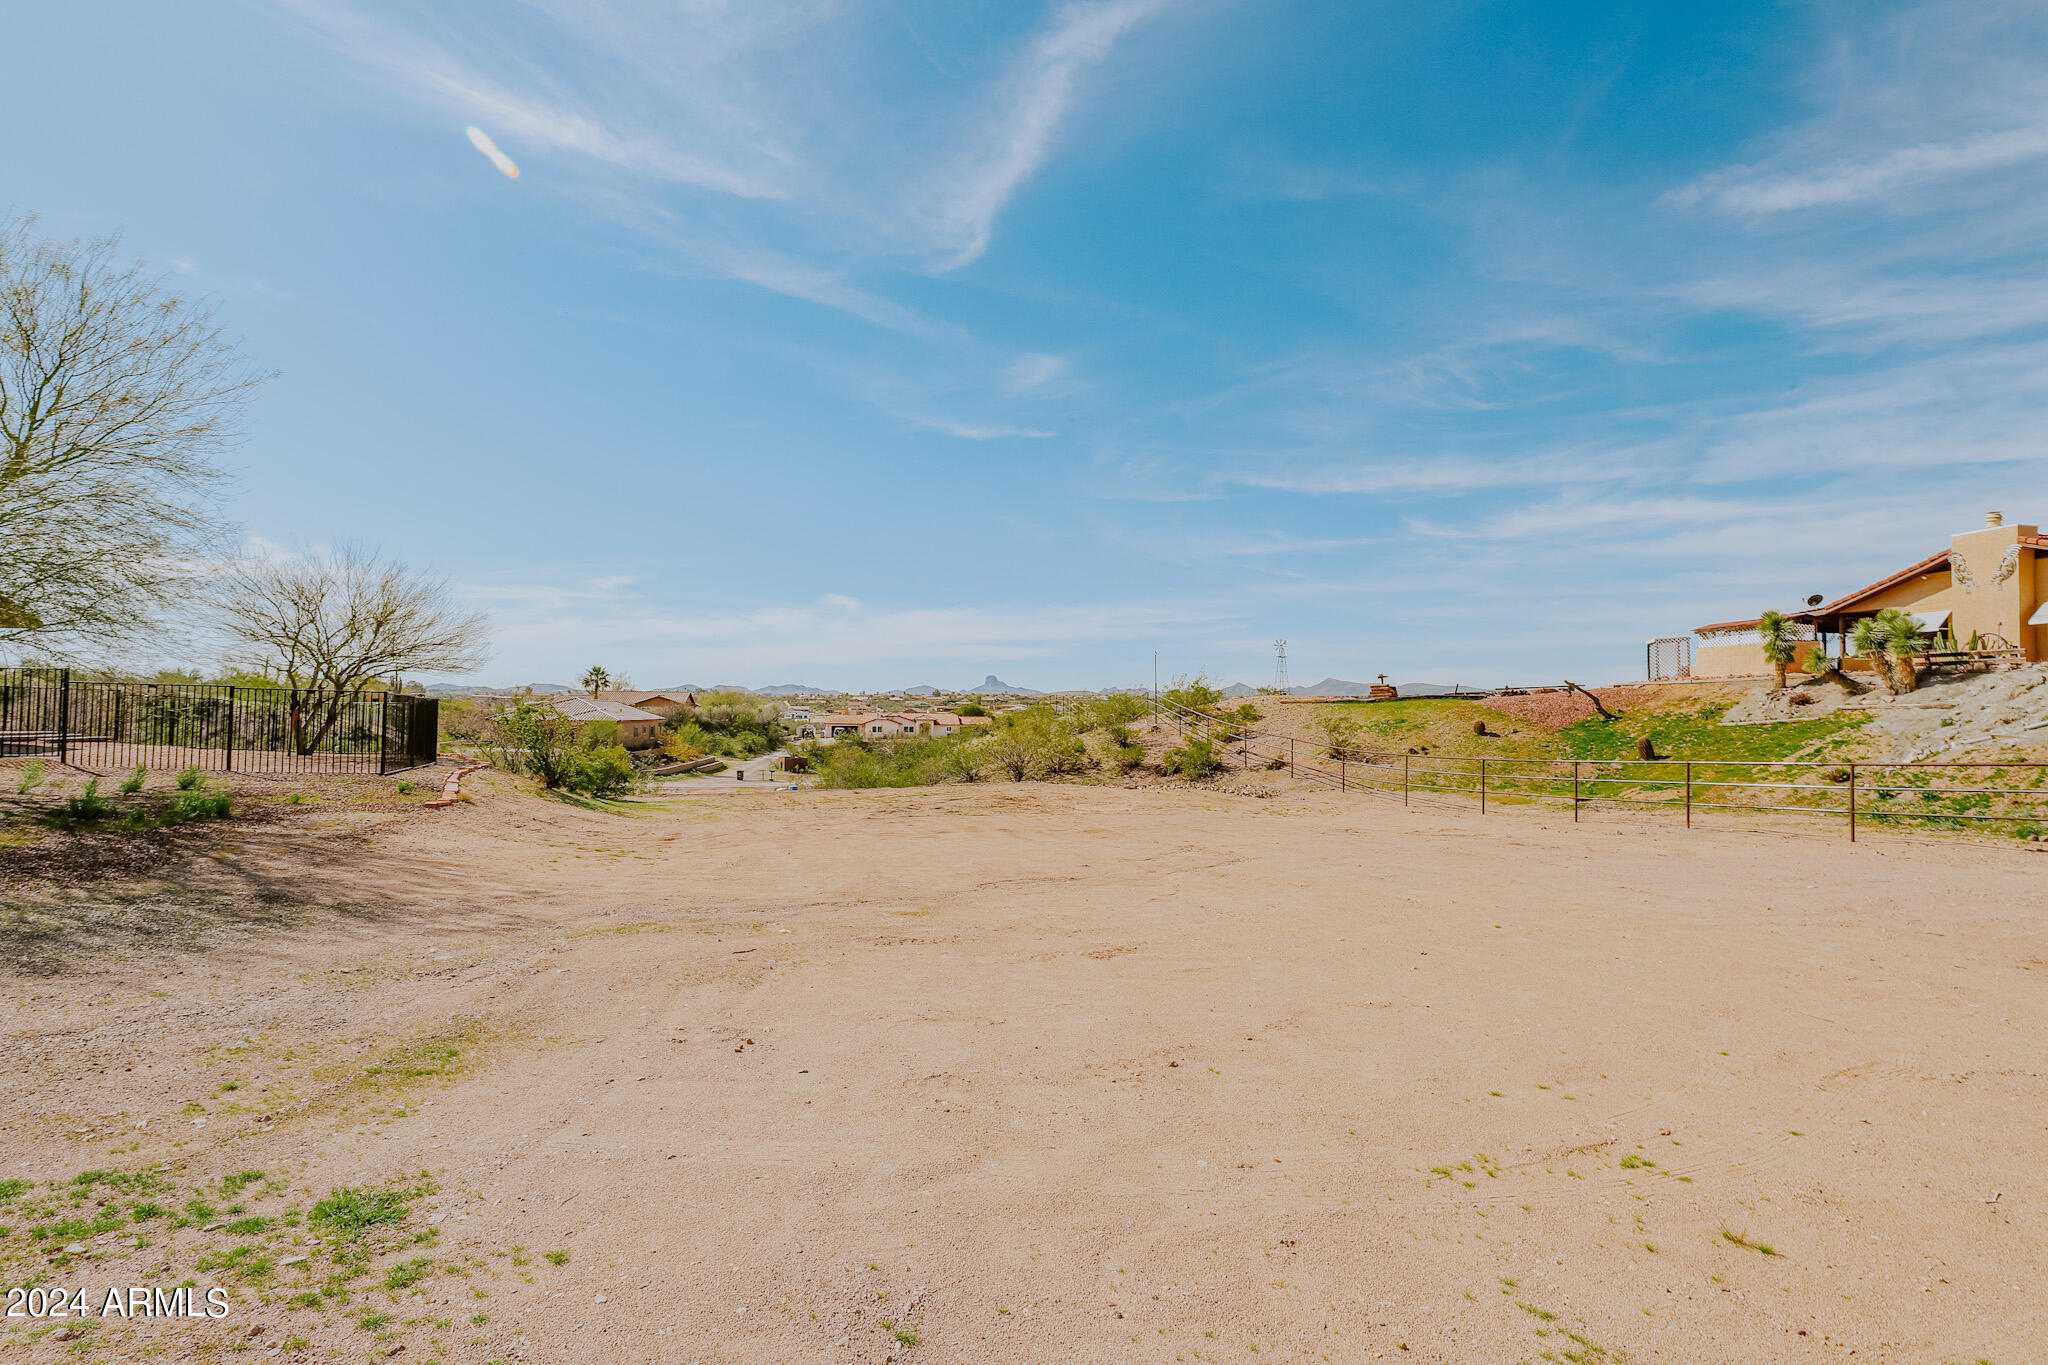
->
[209,546,489,753]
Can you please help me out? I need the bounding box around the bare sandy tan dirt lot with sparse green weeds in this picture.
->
[0,780,2048,1365]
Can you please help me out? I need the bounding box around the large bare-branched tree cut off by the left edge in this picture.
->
[0,215,266,657]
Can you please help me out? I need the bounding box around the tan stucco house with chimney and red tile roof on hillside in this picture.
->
[1692,512,2048,677]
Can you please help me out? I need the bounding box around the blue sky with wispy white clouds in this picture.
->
[0,0,2048,688]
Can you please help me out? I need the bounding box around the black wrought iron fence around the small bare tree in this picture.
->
[0,669,440,774]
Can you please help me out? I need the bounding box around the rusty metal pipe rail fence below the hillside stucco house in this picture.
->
[1151,698,2048,843]
